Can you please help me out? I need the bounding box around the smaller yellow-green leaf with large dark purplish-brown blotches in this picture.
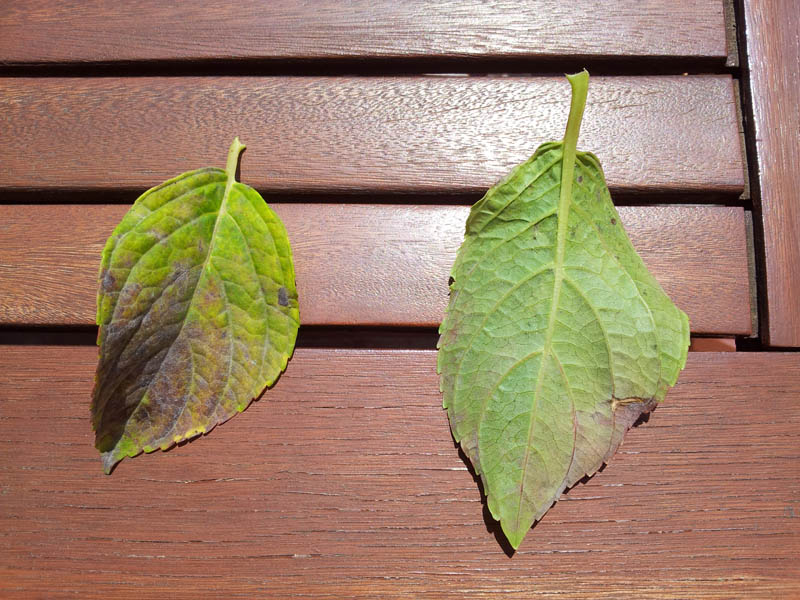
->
[92,138,299,473]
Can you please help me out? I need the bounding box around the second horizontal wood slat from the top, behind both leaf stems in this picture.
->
[0,76,743,196]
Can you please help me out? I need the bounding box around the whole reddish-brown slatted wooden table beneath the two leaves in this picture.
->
[0,0,800,599]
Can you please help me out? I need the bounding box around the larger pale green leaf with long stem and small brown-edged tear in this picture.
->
[438,71,689,548]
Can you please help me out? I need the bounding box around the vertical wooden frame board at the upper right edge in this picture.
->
[744,0,800,346]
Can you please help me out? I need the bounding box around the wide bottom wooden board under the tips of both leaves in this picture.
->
[0,347,800,600]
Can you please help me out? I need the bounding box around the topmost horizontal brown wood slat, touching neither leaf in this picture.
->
[0,0,726,66]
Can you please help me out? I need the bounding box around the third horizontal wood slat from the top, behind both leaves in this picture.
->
[0,203,751,335]
